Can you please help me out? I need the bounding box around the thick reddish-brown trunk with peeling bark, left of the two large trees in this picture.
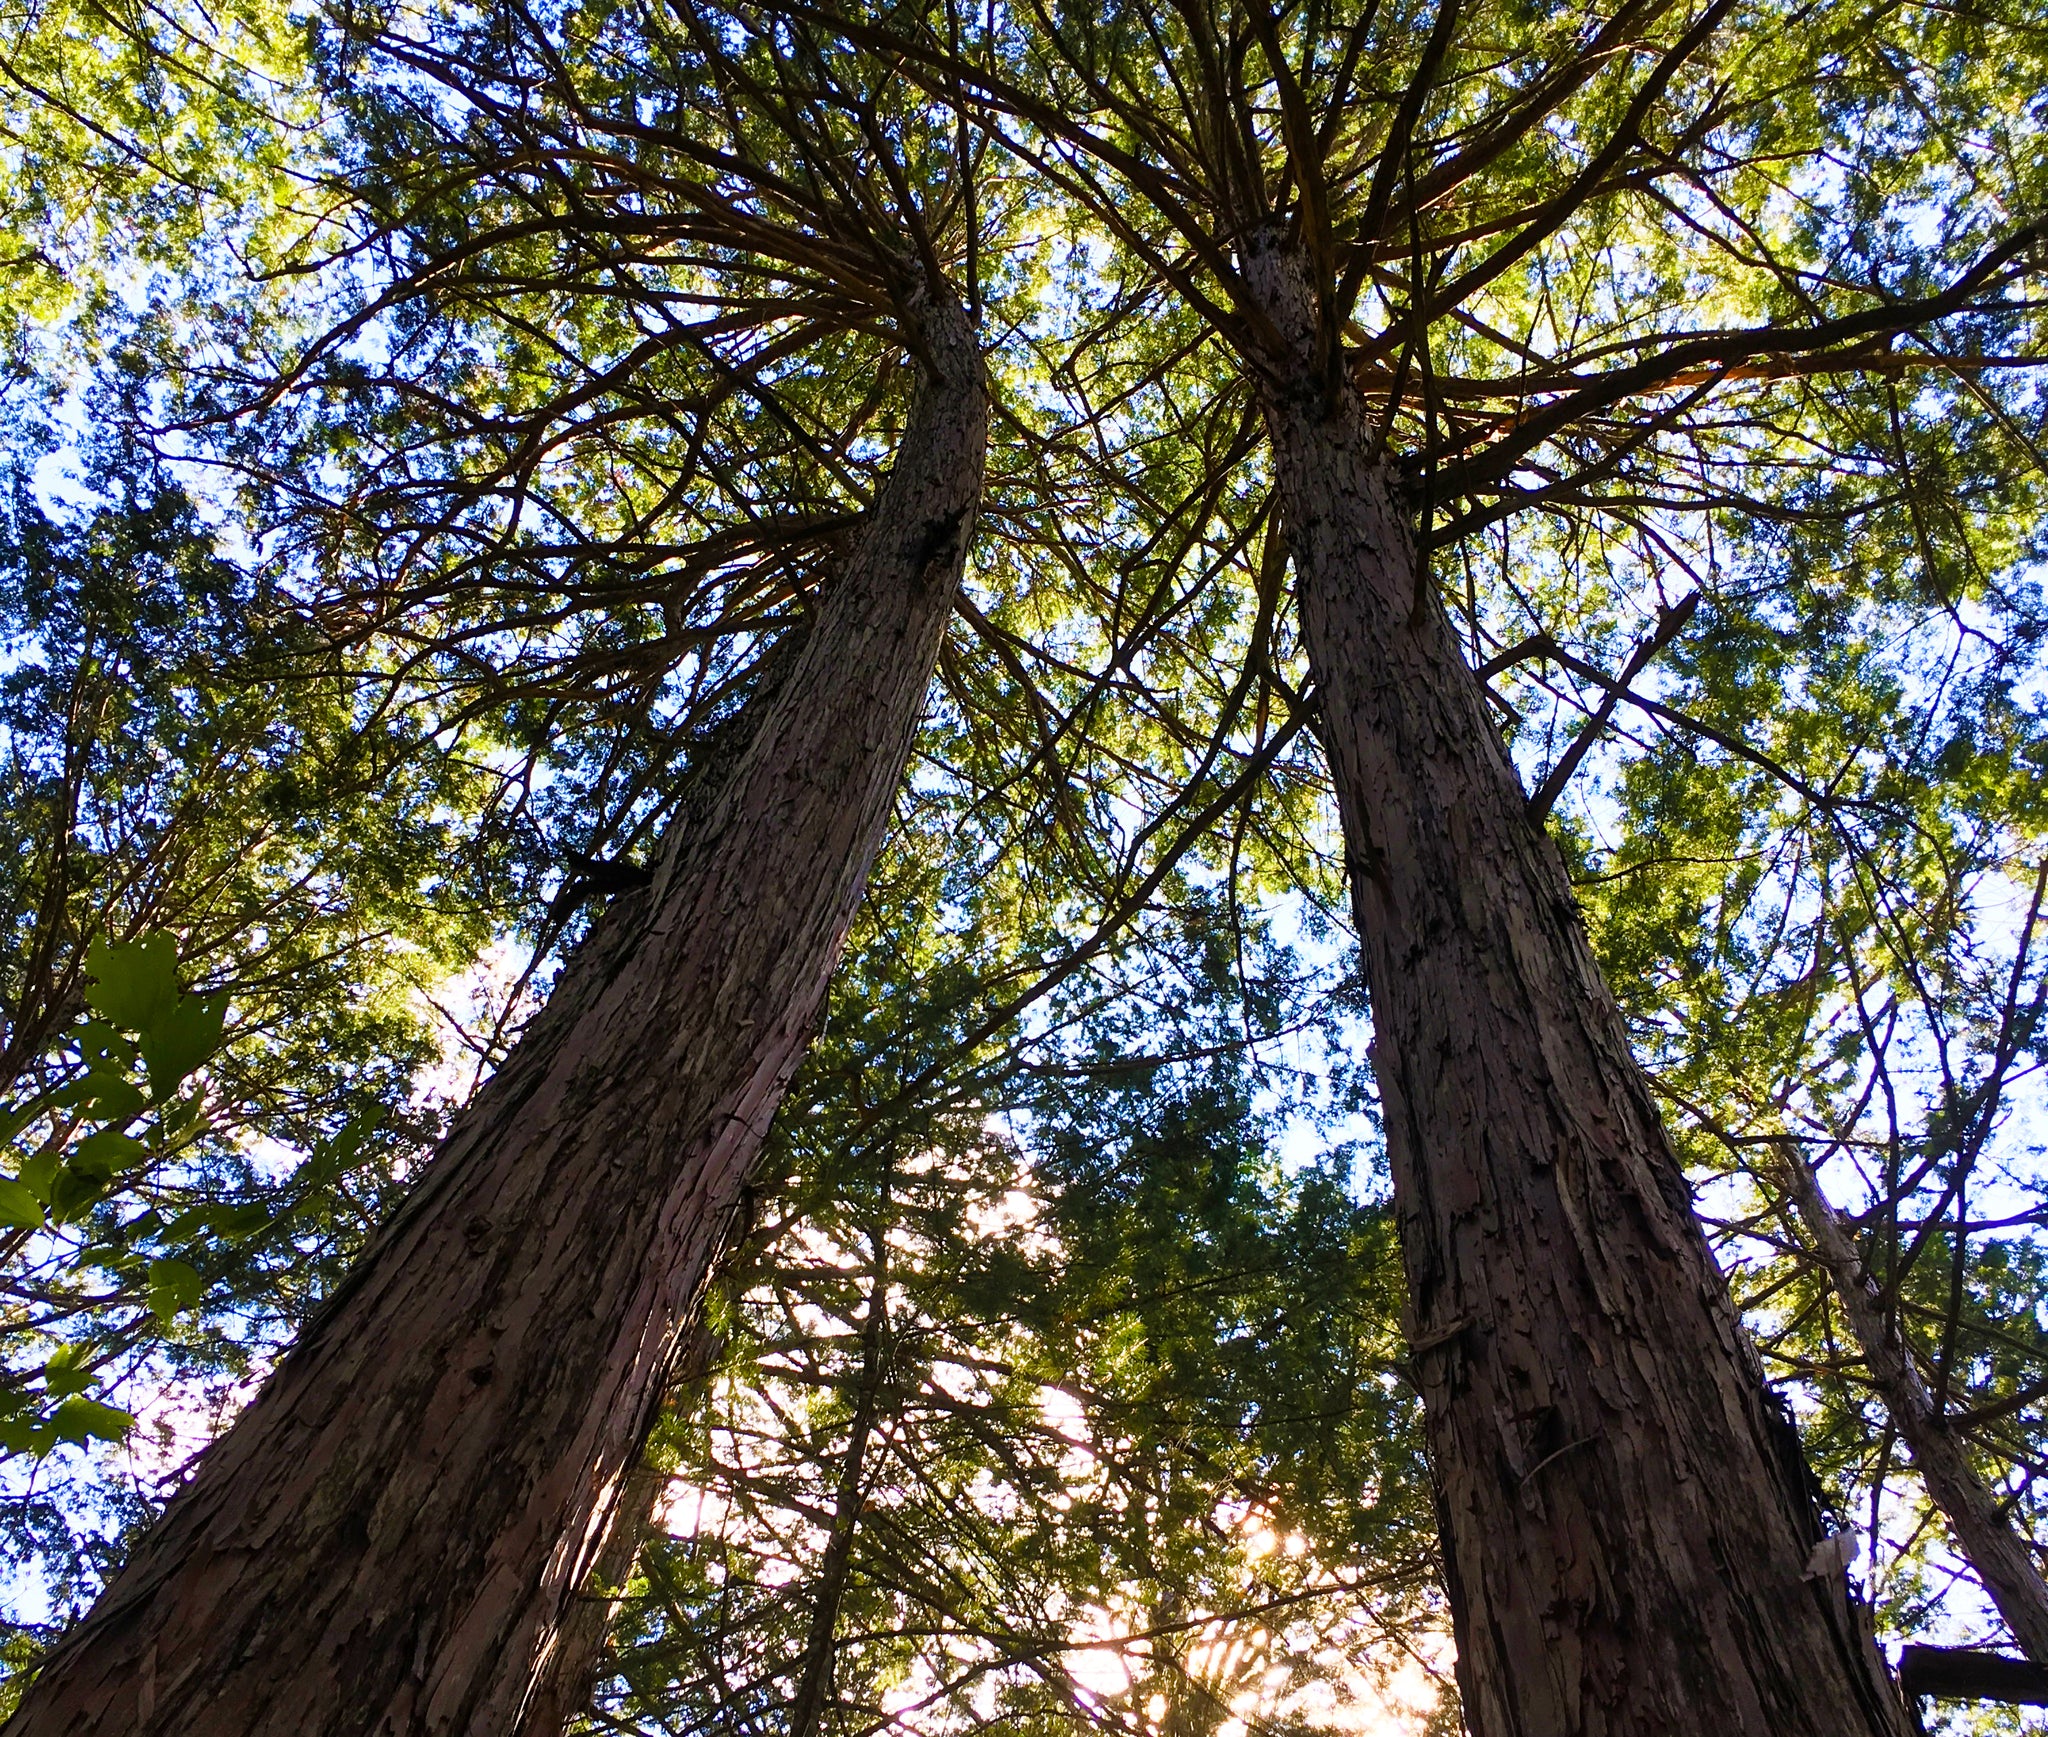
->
[8,290,987,1737]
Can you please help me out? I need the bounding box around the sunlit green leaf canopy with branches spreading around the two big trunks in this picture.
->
[0,0,2048,1737]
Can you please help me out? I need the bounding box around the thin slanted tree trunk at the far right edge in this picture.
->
[1778,1141,2048,1665]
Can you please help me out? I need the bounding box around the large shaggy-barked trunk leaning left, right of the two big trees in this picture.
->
[1243,238,1903,1737]
